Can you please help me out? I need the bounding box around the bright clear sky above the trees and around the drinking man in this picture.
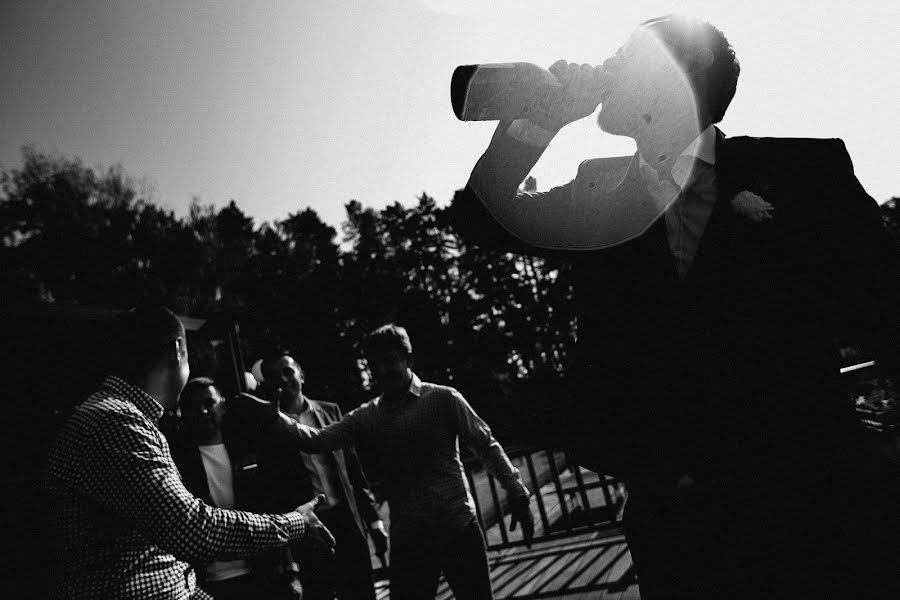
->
[0,0,900,227]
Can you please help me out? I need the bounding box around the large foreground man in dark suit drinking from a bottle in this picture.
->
[450,16,900,600]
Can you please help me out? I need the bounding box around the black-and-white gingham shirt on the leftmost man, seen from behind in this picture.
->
[47,377,305,599]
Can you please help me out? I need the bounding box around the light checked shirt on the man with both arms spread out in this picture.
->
[286,375,528,535]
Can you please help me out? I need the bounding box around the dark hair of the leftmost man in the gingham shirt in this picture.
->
[109,305,185,376]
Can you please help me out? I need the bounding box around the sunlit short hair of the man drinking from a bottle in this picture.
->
[641,15,741,123]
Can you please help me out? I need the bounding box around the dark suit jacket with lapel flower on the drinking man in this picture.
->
[450,123,900,488]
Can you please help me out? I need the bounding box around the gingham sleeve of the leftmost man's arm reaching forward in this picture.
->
[84,412,306,562]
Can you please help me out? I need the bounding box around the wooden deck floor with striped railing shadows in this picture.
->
[376,462,640,600]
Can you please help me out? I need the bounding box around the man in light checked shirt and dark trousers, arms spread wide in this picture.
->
[266,324,534,600]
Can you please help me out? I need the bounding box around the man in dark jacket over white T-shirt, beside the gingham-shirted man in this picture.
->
[169,377,303,600]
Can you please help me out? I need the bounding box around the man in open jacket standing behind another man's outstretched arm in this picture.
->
[257,351,387,600]
